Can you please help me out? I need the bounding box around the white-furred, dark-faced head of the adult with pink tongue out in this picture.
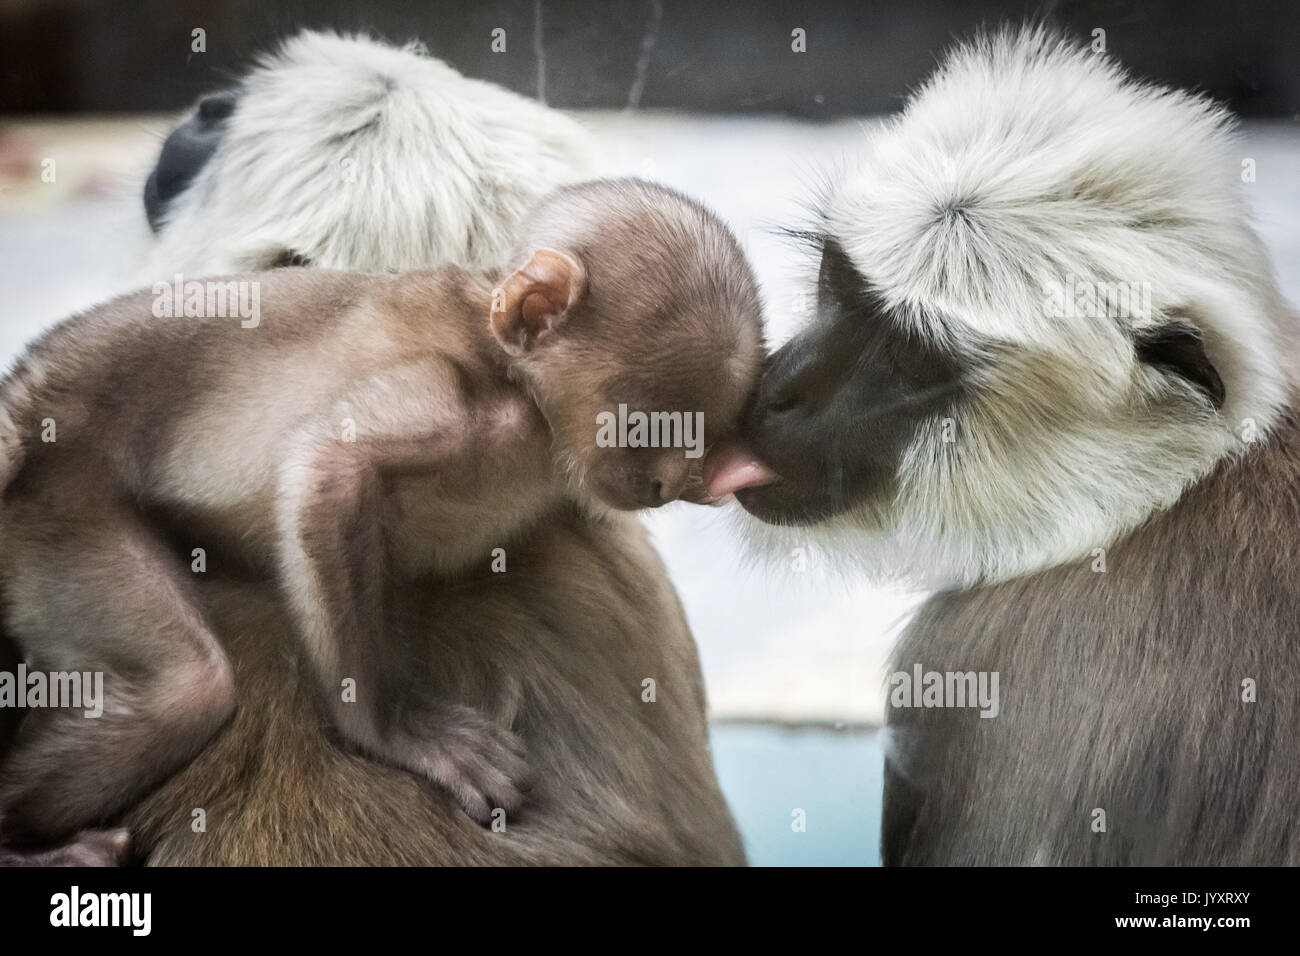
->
[710,30,1292,584]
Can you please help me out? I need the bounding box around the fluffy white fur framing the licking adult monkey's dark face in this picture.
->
[759,30,1295,585]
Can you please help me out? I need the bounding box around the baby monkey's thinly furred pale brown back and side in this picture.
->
[0,269,488,522]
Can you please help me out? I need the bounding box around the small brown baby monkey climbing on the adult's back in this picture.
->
[0,179,764,842]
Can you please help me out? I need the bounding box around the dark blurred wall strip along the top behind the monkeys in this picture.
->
[0,0,1300,118]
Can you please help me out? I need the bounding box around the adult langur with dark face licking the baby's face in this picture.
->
[712,30,1300,864]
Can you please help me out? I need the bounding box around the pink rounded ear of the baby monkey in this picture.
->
[491,248,586,355]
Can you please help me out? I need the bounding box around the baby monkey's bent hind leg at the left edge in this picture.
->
[0,502,235,844]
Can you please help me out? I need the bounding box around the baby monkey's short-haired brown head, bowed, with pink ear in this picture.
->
[491,179,764,509]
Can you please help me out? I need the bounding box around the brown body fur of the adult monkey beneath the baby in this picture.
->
[125,511,745,866]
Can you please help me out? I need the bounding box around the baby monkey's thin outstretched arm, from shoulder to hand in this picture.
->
[277,367,527,822]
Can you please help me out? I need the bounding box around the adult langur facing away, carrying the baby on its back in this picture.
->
[0,27,745,865]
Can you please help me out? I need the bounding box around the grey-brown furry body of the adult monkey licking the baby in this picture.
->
[883,406,1300,866]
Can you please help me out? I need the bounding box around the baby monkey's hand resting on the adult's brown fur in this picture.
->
[380,697,530,825]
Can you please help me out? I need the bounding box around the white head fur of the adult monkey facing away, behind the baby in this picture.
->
[146,33,595,281]
